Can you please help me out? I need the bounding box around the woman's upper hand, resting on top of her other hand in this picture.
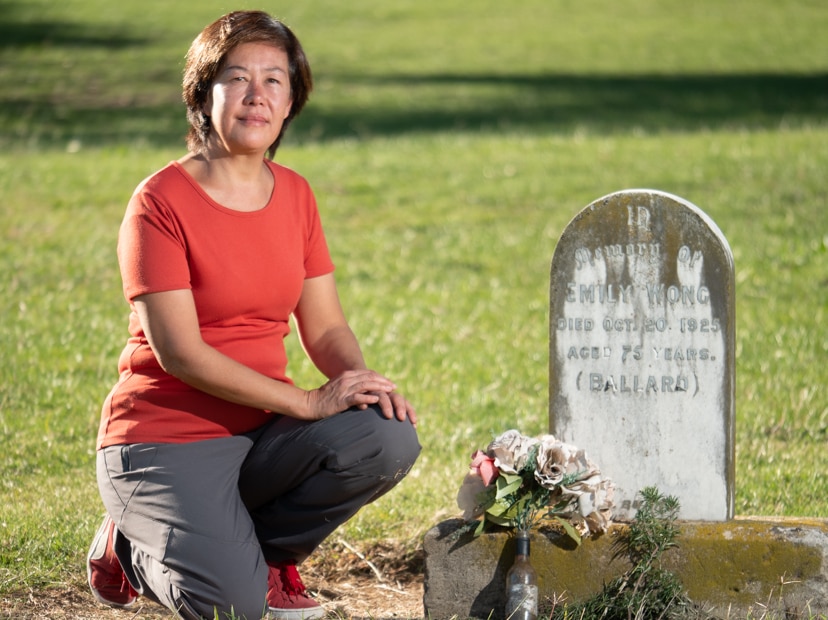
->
[307,369,397,420]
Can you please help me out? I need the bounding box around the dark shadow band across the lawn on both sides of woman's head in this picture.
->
[0,74,828,147]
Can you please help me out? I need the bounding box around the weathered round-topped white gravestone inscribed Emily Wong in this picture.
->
[549,190,735,521]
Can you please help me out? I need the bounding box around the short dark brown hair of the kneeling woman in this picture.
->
[182,11,313,159]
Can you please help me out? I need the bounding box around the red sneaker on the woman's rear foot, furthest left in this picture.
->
[86,515,138,608]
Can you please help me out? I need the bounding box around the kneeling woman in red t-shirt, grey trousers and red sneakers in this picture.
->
[87,11,420,620]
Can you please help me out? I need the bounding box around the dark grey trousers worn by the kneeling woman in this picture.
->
[97,408,420,620]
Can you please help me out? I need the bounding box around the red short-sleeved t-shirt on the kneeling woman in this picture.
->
[97,161,334,448]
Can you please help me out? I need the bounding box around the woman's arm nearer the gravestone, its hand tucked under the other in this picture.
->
[294,274,417,425]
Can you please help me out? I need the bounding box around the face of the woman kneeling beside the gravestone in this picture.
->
[204,43,292,155]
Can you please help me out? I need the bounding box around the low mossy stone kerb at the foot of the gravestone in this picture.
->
[423,517,828,620]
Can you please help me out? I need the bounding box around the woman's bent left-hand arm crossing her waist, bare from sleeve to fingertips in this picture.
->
[133,289,394,420]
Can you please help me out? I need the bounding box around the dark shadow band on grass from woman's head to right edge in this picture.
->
[300,74,828,137]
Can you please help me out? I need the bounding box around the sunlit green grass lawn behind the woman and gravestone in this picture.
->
[0,0,828,604]
